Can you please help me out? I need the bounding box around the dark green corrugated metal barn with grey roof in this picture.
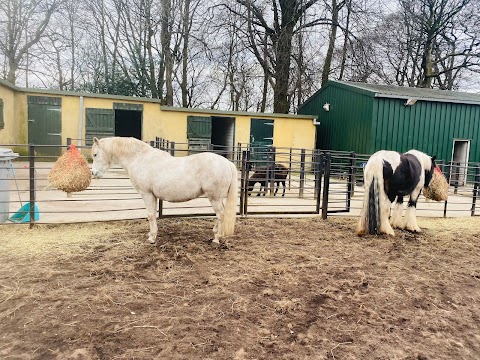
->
[299,81,480,164]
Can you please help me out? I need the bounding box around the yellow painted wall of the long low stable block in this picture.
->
[0,84,315,156]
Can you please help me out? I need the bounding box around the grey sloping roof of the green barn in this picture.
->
[327,81,480,105]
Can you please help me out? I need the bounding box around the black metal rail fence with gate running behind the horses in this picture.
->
[0,138,480,226]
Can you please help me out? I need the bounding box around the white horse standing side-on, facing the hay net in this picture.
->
[92,137,238,245]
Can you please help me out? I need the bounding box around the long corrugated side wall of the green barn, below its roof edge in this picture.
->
[372,98,480,162]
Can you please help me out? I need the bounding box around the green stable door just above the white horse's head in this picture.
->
[85,108,115,146]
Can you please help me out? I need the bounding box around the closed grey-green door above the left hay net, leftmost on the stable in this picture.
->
[27,96,62,156]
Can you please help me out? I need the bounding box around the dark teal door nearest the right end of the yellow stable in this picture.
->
[250,119,273,165]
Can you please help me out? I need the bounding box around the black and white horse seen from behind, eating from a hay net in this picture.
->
[357,150,435,235]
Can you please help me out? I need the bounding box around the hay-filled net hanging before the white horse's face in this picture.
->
[48,145,92,193]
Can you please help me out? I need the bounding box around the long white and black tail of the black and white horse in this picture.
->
[357,157,384,235]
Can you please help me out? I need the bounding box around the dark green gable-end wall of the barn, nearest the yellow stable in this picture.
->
[299,85,373,154]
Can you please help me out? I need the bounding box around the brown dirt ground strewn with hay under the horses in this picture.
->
[0,217,480,360]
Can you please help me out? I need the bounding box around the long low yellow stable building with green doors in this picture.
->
[0,80,317,157]
